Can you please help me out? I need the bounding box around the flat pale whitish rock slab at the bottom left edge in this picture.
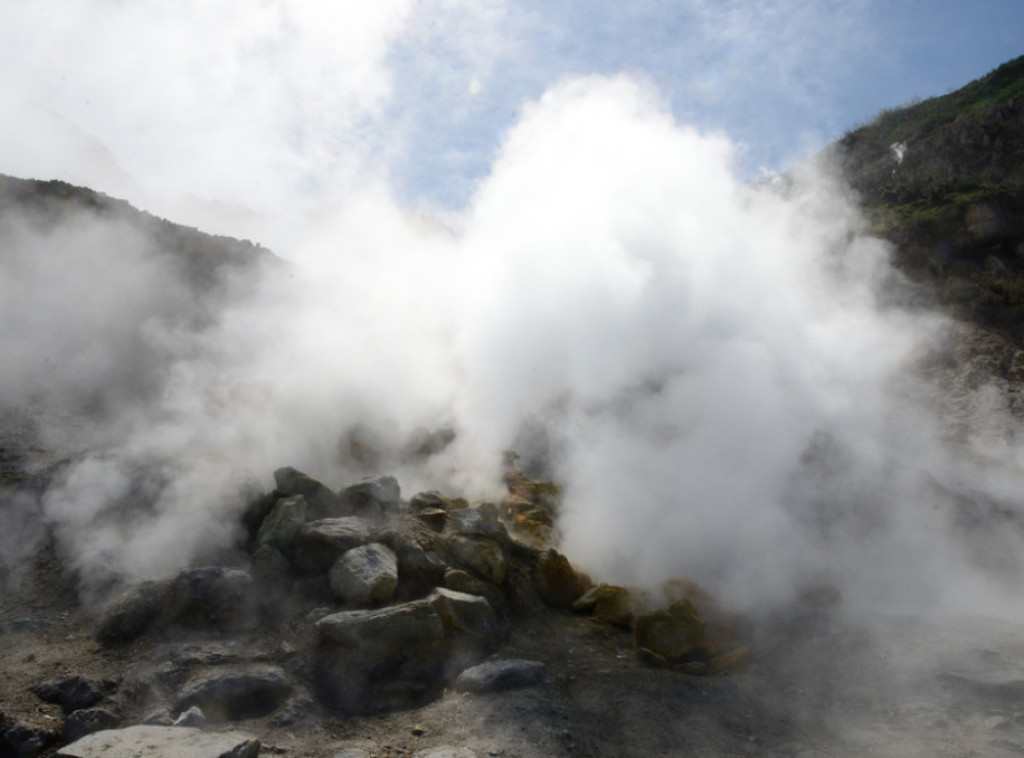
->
[57,726,259,758]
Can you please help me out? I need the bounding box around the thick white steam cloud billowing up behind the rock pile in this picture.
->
[0,78,1020,607]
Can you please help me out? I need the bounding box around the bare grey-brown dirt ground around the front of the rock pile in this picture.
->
[6,540,1024,758]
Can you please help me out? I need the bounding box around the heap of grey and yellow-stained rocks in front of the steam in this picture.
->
[5,458,749,756]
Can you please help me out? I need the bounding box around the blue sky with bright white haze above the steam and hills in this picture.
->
[0,0,1024,219]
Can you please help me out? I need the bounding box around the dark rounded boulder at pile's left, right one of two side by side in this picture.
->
[167,565,255,632]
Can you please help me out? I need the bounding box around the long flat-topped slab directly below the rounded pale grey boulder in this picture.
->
[316,599,445,647]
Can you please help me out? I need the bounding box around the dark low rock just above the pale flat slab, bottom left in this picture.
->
[177,666,292,721]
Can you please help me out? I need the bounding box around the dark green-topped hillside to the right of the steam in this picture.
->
[828,56,1024,347]
